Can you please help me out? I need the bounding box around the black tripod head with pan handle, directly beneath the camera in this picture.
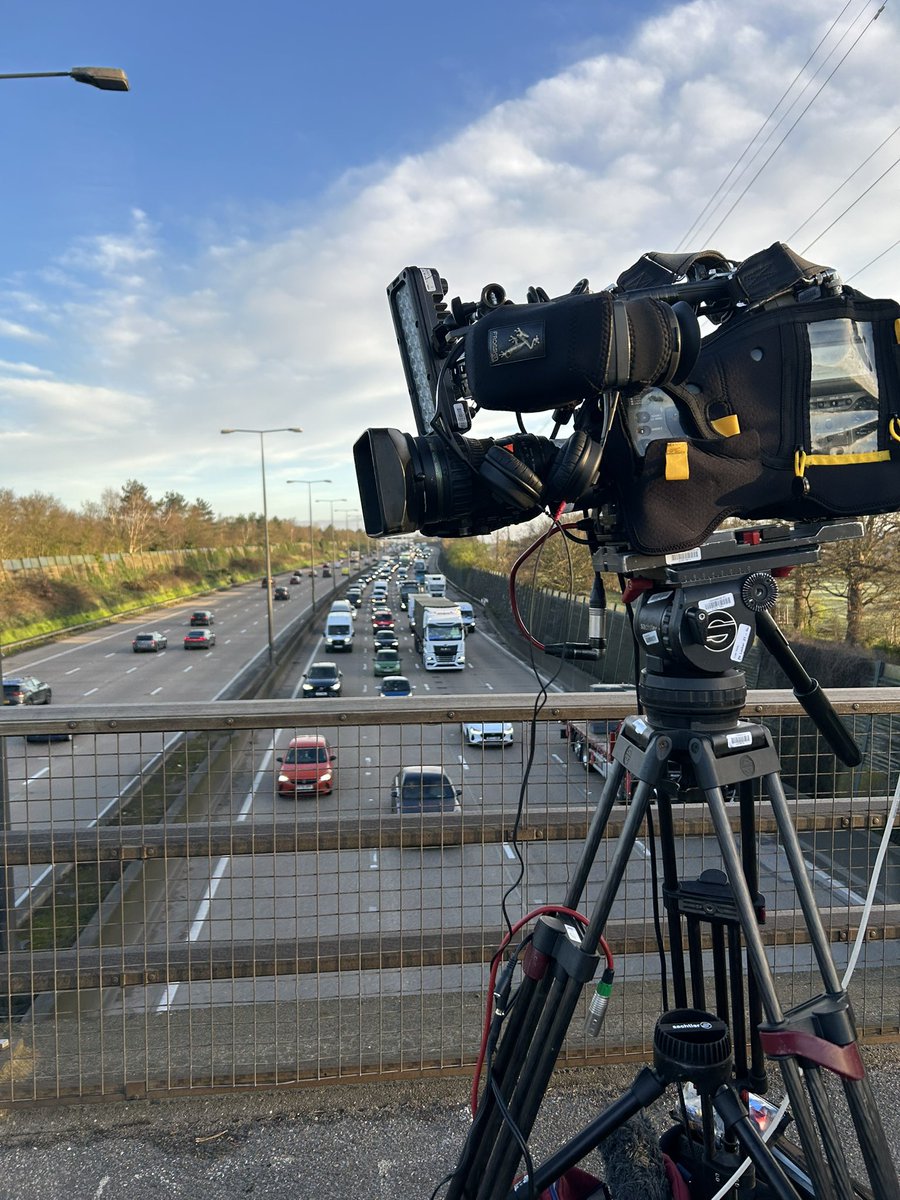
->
[593,521,863,767]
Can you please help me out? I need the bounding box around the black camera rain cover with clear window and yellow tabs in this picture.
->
[604,288,900,553]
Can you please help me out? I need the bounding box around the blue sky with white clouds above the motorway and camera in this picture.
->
[0,0,900,527]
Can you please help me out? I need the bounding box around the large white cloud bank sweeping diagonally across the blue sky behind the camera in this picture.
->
[0,0,900,512]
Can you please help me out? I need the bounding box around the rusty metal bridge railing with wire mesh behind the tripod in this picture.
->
[0,689,900,1104]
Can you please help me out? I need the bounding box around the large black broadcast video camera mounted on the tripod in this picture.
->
[354,242,900,553]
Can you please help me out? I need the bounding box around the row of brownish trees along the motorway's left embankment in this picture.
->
[0,479,359,559]
